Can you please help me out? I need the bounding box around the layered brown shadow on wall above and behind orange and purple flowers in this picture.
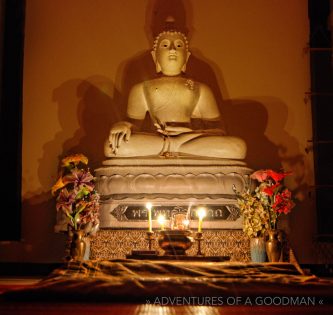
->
[9,76,121,262]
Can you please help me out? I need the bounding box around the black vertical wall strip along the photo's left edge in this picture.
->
[0,0,25,240]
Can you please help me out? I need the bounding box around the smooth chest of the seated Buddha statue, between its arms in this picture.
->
[145,78,199,121]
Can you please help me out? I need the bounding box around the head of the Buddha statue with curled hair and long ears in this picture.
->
[152,32,190,76]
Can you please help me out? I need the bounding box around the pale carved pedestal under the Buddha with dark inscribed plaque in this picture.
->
[95,157,252,229]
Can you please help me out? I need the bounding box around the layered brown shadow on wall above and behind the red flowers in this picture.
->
[223,97,316,261]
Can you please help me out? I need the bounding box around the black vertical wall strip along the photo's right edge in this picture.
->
[309,0,333,235]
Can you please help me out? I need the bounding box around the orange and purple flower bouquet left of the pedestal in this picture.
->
[51,154,99,230]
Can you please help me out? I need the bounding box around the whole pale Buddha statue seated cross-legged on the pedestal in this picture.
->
[104,30,246,160]
